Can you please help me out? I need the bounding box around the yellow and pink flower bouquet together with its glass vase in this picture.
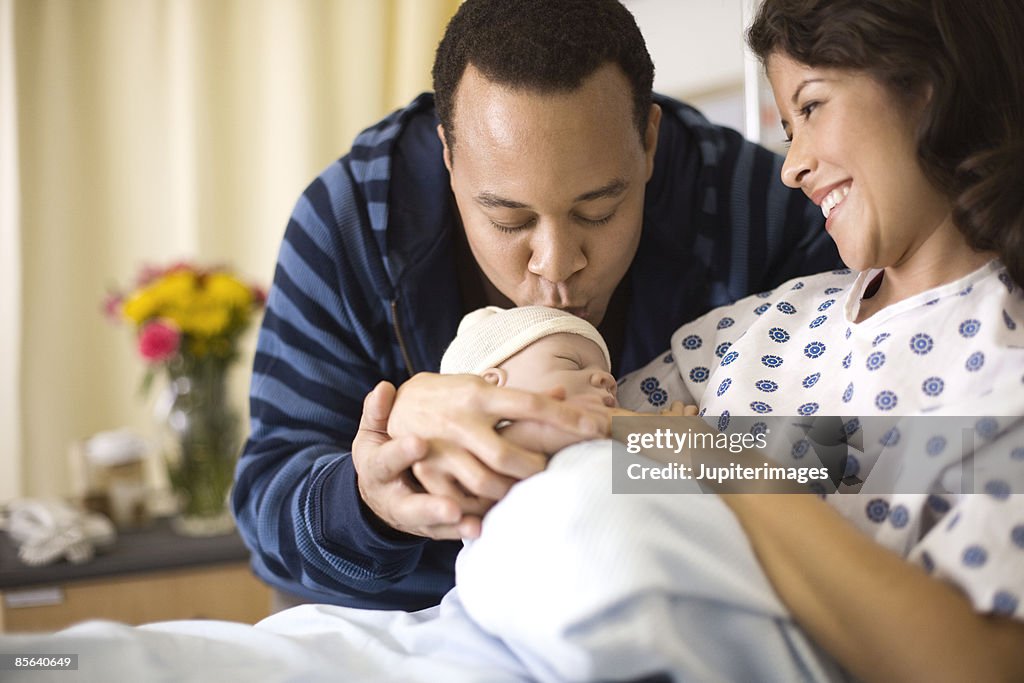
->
[104,262,266,536]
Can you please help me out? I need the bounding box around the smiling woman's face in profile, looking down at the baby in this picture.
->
[767,53,955,270]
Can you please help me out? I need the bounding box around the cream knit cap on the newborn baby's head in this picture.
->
[441,306,611,375]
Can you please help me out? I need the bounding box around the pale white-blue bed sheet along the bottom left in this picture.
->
[0,593,530,683]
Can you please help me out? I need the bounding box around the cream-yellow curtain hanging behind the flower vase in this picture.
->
[0,0,459,501]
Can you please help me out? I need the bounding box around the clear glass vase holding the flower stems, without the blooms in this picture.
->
[157,355,241,536]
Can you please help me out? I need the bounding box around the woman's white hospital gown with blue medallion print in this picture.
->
[620,261,1024,620]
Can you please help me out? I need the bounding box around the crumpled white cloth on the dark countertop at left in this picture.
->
[0,499,117,566]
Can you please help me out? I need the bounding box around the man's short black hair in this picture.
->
[433,0,654,150]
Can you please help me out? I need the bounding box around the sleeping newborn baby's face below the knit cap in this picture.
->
[500,333,618,408]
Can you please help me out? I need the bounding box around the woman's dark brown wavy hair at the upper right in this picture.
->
[746,0,1024,286]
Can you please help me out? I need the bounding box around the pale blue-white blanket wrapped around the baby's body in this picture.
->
[455,441,846,683]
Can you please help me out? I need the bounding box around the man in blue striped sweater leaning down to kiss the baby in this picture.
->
[233,0,839,609]
